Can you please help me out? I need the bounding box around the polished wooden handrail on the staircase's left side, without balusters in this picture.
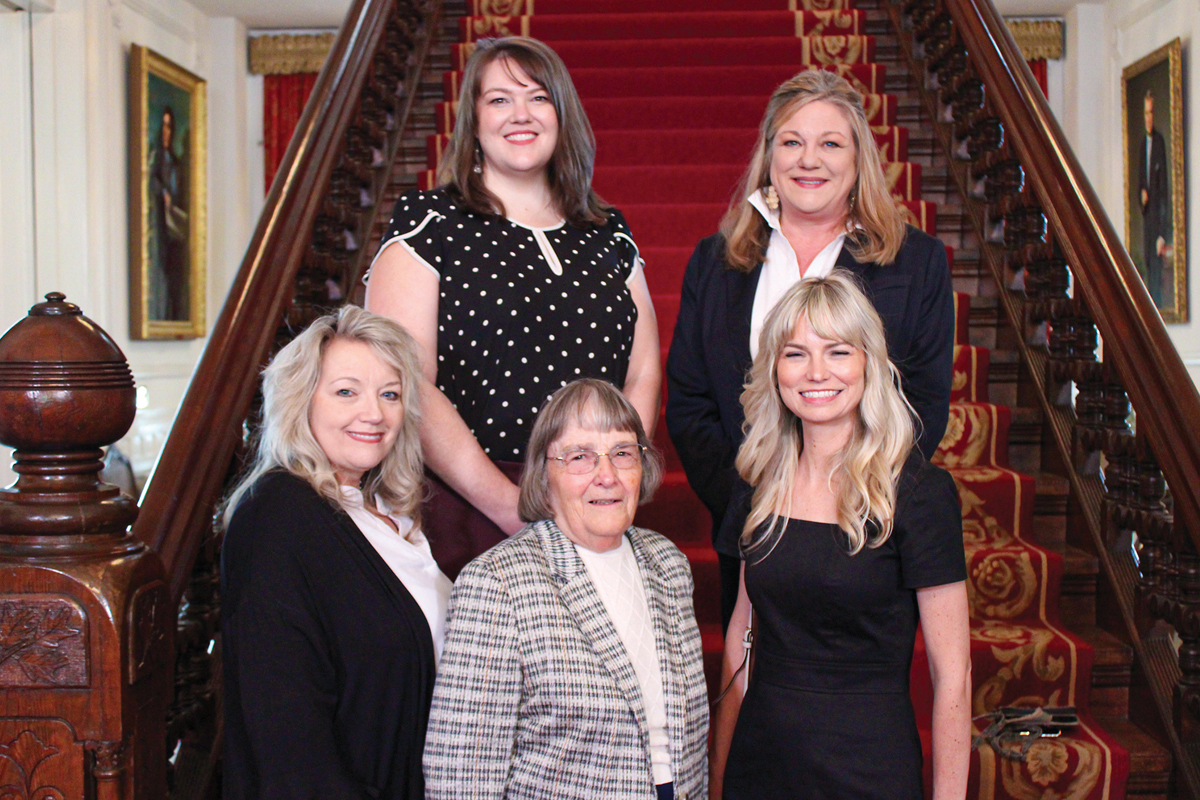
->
[133,0,394,606]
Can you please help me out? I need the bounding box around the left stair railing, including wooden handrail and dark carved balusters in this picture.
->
[133,0,442,798]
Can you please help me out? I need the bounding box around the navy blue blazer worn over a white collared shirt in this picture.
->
[666,227,954,557]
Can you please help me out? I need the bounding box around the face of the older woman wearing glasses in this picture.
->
[546,421,642,553]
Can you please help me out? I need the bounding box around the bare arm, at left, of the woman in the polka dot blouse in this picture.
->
[365,242,523,535]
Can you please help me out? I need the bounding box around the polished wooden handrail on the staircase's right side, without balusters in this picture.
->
[946,0,1200,547]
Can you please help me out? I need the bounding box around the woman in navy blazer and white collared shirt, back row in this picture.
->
[666,71,954,624]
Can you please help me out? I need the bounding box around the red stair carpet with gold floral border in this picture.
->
[421,0,1129,800]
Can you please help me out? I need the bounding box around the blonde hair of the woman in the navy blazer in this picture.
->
[721,70,905,272]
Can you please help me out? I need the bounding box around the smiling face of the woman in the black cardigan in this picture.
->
[308,338,404,487]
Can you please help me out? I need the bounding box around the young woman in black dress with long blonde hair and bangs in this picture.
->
[712,271,971,800]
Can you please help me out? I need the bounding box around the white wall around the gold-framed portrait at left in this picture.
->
[0,0,255,491]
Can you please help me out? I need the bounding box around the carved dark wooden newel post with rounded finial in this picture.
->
[0,293,173,800]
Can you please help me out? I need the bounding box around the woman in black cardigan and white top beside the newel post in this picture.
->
[221,307,450,800]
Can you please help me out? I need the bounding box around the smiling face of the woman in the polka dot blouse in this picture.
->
[475,58,558,183]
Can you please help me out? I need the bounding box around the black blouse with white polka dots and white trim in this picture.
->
[376,190,640,461]
